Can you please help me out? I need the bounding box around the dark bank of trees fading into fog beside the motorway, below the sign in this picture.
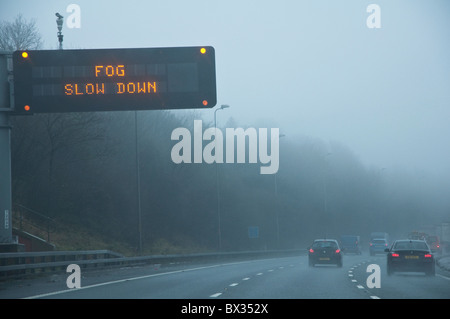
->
[8,111,446,255]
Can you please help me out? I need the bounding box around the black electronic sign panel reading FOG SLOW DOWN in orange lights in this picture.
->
[13,46,217,114]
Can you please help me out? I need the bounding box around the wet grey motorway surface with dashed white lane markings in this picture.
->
[0,255,450,300]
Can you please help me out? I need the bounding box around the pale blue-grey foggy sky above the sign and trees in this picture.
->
[0,0,450,176]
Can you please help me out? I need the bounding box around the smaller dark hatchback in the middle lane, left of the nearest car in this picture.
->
[308,239,342,267]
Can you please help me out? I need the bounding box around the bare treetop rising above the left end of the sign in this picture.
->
[0,14,42,51]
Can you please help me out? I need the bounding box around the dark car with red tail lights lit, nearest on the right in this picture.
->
[386,239,435,276]
